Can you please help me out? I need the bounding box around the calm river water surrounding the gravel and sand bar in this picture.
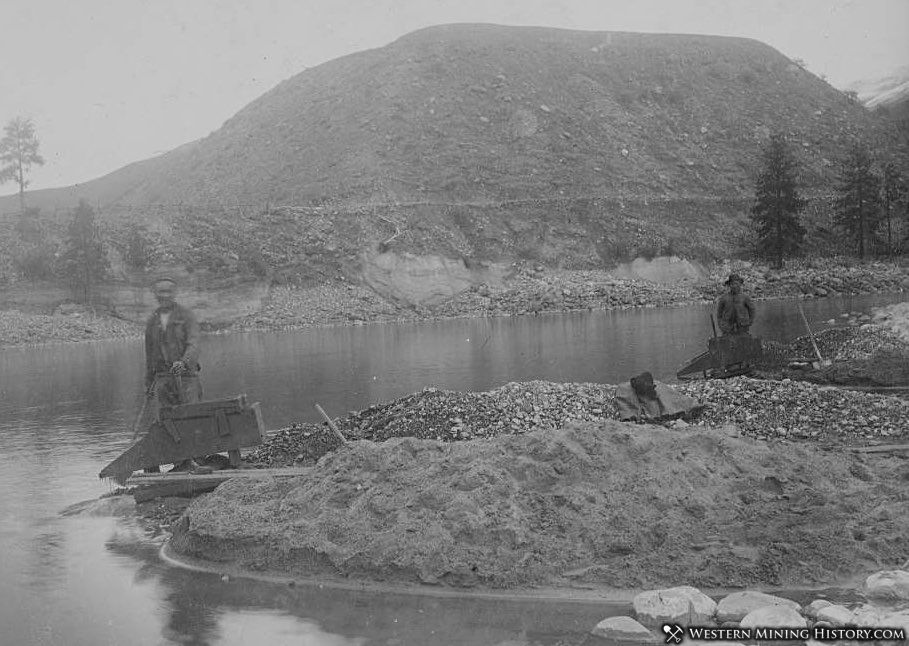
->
[0,295,905,646]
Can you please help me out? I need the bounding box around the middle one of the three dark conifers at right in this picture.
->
[836,144,881,260]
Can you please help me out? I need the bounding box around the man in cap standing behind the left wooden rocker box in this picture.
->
[145,277,202,471]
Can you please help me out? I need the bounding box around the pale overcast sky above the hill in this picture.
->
[0,0,909,194]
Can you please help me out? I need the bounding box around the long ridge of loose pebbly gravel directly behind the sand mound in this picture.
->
[247,377,909,467]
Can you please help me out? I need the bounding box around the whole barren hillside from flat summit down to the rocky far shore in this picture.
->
[0,24,903,272]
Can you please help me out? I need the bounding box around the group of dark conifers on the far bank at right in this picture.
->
[751,133,909,268]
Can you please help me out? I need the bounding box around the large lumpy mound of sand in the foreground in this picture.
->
[172,421,909,588]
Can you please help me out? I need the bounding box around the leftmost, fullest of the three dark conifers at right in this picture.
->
[751,134,805,268]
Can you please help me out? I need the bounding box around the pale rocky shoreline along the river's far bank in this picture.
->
[0,260,909,349]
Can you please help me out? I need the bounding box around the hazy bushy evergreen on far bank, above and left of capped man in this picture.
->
[61,200,110,303]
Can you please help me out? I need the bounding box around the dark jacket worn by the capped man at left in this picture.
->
[145,305,199,387]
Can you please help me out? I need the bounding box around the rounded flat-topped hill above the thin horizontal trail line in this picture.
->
[10,24,904,210]
